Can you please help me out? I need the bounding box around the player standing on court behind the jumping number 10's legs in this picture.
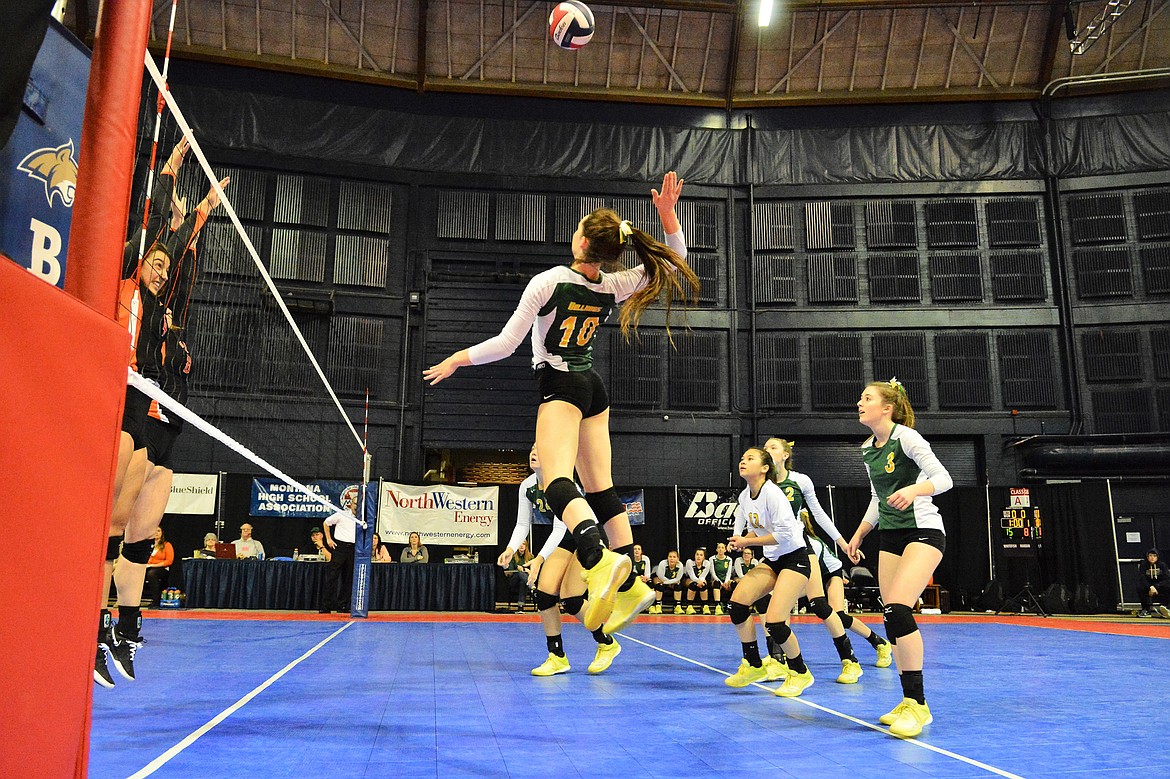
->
[496,446,621,676]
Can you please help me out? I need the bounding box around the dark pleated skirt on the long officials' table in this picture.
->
[183,559,496,612]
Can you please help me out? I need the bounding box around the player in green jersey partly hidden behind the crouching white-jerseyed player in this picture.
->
[764,436,861,684]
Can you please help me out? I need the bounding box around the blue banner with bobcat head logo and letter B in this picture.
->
[0,21,90,288]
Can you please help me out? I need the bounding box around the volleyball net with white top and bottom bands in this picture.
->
[122,51,370,526]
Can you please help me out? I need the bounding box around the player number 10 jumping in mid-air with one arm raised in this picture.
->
[422,171,698,634]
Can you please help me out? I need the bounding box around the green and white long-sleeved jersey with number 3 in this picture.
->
[861,425,954,532]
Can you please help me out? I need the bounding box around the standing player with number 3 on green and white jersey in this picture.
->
[849,379,952,738]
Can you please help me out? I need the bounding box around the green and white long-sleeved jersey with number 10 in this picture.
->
[468,230,687,371]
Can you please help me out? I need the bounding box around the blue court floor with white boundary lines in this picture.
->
[90,615,1170,779]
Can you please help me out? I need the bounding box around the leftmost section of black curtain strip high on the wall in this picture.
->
[177,88,745,185]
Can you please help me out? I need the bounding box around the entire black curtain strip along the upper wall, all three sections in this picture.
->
[176,78,1170,186]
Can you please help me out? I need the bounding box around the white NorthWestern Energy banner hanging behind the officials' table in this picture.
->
[378,482,500,546]
